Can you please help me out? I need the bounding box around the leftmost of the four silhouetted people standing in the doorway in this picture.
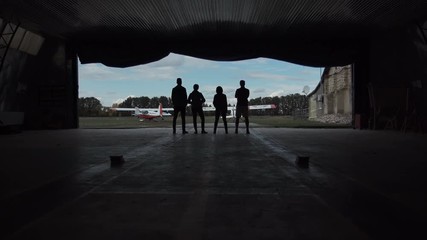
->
[172,78,188,134]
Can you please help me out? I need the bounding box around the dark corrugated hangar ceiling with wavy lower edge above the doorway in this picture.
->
[0,0,427,67]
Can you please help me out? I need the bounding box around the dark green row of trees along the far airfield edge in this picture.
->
[79,93,308,116]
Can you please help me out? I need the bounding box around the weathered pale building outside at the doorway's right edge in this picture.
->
[308,65,353,122]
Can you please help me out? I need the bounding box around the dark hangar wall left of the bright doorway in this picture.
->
[0,24,78,129]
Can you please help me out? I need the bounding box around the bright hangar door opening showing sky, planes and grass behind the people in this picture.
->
[79,54,351,128]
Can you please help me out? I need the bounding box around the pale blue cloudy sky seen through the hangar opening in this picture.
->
[79,54,323,107]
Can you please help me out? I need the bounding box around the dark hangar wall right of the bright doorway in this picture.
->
[354,24,427,131]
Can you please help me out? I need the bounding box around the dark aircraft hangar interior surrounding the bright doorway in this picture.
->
[0,0,427,239]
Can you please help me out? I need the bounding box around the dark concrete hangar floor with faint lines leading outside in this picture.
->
[0,128,427,240]
